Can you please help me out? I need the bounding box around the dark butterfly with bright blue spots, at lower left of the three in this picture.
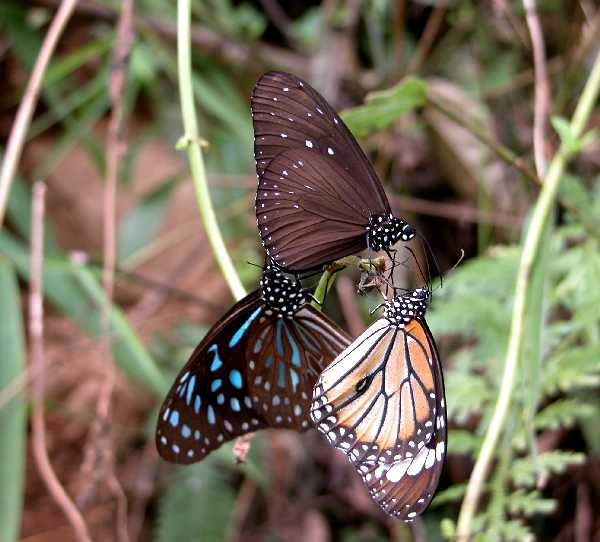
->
[156,265,350,464]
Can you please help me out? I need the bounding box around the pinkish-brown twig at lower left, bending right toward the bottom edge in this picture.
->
[29,182,91,542]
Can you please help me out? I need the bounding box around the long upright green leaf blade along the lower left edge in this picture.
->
[0,255,27,542]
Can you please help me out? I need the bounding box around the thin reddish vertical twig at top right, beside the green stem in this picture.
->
[523,0,550,179]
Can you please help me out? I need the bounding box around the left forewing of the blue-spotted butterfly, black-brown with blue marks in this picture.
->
[156,291,268,464]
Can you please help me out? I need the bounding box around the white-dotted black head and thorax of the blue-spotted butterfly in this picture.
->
[260,265,307,318]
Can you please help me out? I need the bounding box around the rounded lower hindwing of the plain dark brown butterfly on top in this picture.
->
[256,148,370,271]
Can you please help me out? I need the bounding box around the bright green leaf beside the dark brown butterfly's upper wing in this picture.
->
[341,77,427,137]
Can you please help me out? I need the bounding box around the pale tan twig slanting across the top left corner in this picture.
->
[0,0,77,227]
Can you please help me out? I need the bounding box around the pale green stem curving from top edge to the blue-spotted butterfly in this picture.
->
[177,0,246,300]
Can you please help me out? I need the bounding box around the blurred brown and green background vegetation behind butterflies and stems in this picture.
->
[0,0,600,542]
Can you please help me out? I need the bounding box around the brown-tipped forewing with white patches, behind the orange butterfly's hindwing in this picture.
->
[358,323,446,521]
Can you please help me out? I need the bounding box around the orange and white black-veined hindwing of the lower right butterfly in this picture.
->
[311,318,439,464]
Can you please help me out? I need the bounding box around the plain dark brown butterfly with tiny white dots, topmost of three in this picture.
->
[252,72,415,272]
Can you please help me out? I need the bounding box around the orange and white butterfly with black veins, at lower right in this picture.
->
[311,288,446,521]
